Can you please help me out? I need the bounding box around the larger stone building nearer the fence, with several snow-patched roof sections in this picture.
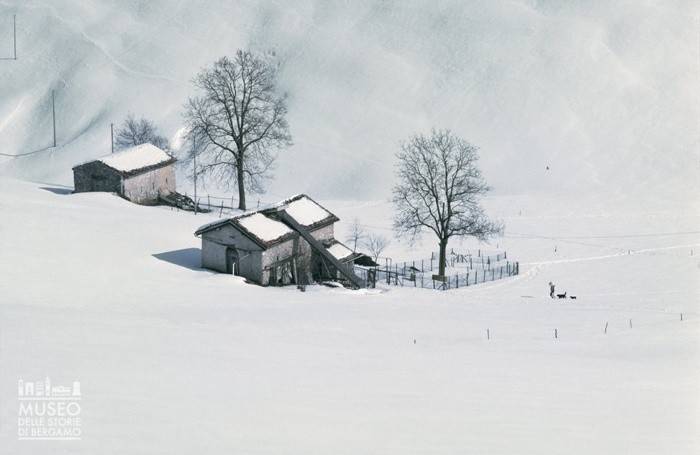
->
[195,194,359,286]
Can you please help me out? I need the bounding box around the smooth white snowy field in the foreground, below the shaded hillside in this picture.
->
[0,179,700,455]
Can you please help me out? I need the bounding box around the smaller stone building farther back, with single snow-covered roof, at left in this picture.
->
[73,144,176,204]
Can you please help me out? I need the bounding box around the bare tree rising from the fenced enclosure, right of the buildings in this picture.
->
[392,130,503,275]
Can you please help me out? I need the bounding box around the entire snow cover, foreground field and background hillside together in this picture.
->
[0,0,700,455]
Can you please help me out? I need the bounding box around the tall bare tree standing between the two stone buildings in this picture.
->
[184,50,291,210]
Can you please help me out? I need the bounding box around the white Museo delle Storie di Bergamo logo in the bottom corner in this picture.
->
[17,376,82,441]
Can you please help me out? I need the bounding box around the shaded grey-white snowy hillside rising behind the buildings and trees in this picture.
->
[0,0,700,199]
